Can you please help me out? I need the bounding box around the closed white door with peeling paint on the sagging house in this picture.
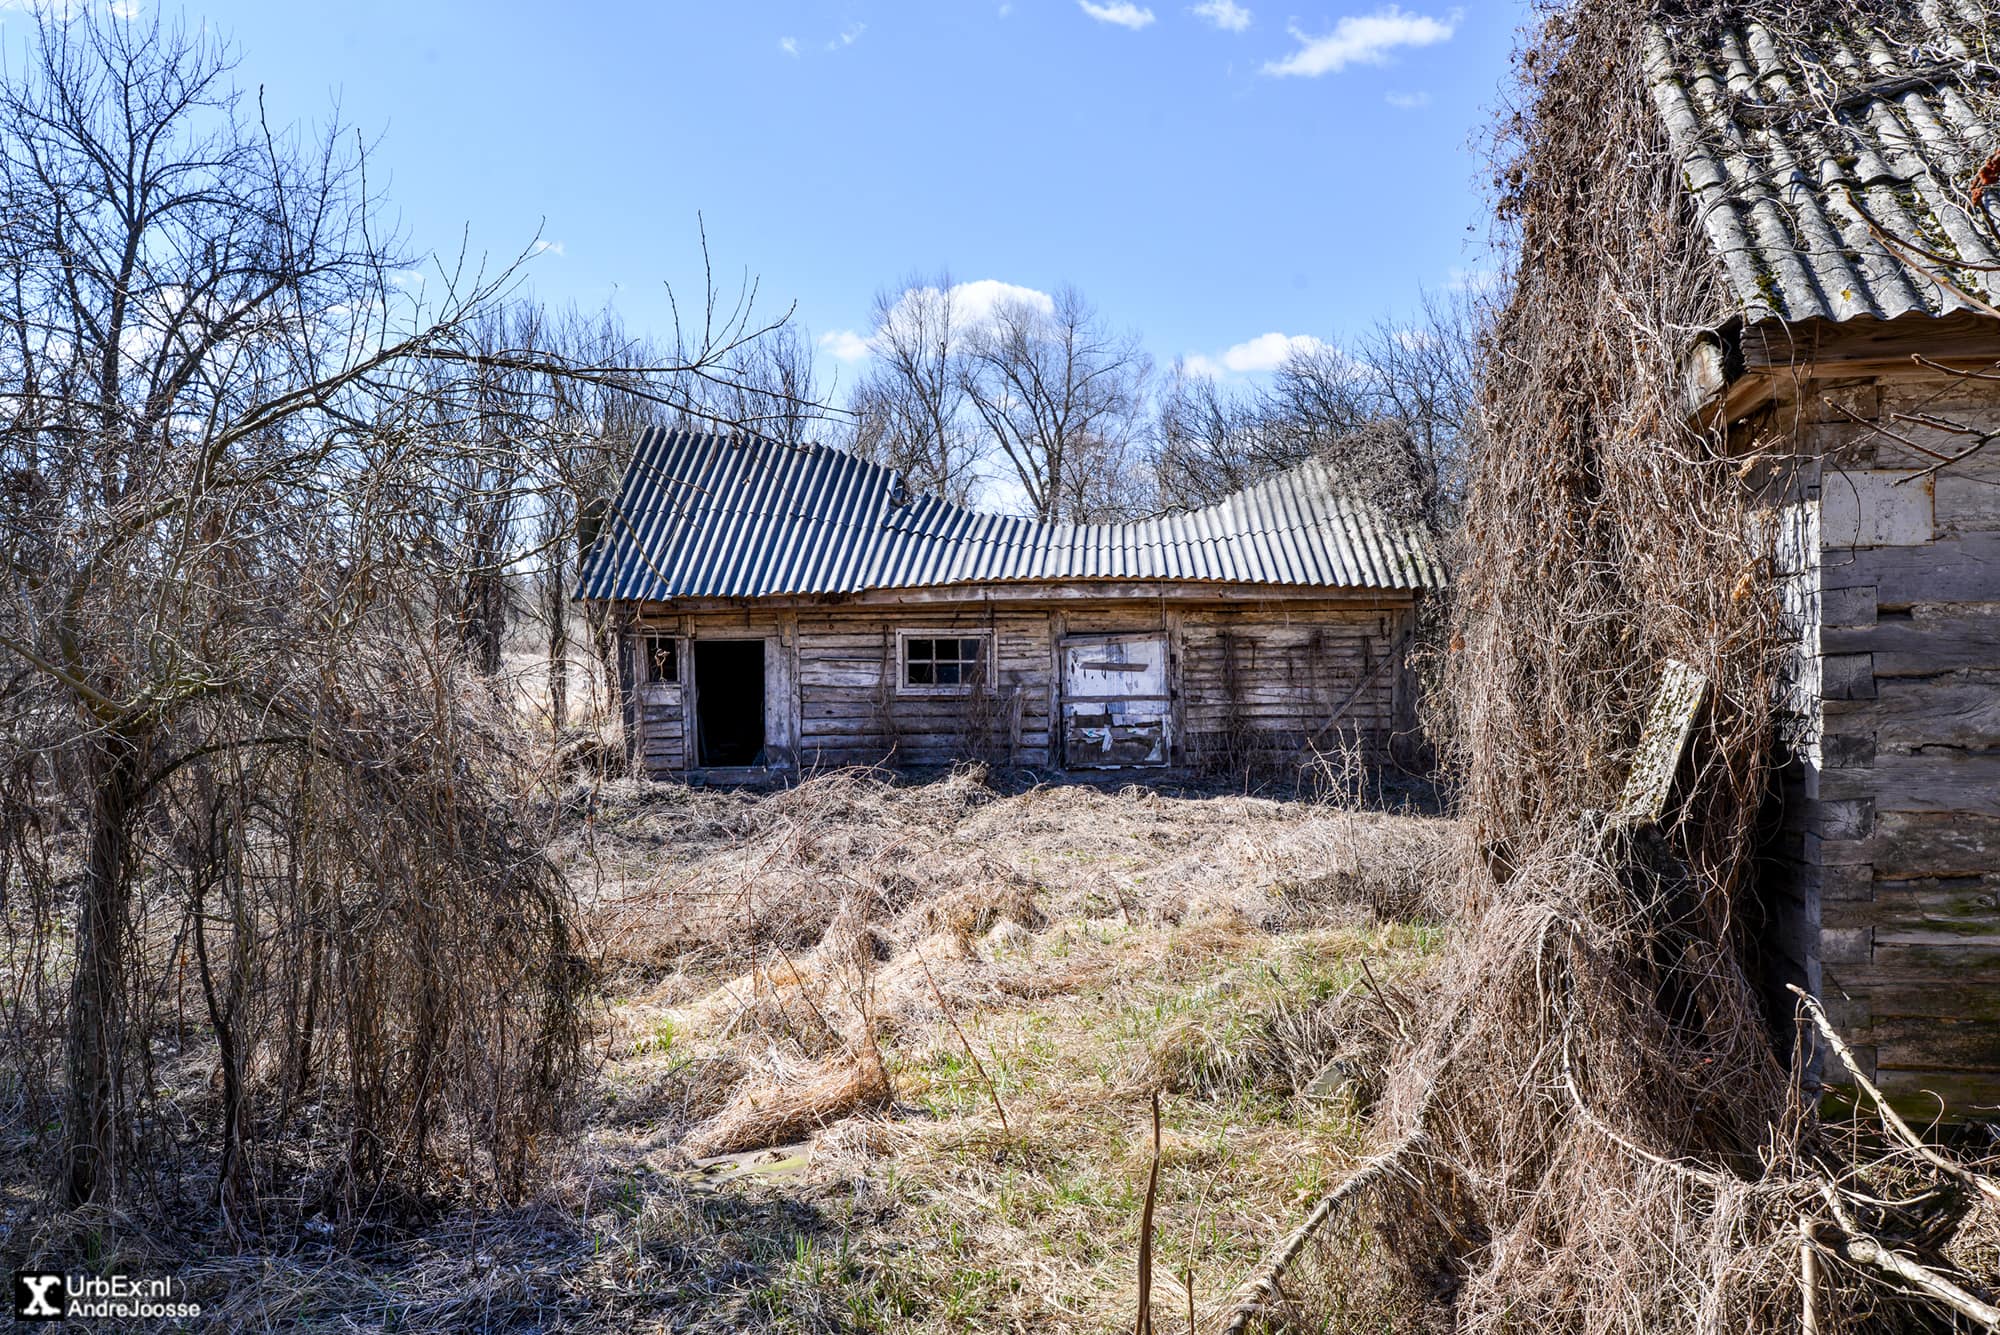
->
[1062,632,1174,769]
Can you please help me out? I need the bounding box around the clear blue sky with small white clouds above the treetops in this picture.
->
[62,0,1526,391]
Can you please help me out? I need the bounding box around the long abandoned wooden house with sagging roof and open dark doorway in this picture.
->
[582,432,1440,779]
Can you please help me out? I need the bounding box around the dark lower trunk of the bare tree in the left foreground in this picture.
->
[64,731,144,1205]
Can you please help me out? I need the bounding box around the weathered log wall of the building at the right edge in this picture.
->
[1774,370,2000,1111]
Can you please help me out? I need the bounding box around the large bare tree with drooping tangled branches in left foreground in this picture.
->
[0,10,772,1219]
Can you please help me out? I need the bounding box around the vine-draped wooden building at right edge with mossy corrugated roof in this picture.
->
[1648,13,2000,1115]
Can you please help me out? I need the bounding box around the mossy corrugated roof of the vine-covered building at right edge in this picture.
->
[1646,0,2000,322]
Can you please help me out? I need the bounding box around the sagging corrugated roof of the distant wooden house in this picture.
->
[580,432,1442,602]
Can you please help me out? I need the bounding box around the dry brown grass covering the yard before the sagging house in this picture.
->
[0,755,1456,1333]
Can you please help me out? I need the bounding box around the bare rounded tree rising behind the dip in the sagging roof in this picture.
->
[960,286,1152,522]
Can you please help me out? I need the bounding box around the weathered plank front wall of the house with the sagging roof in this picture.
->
[626,590,1416,777]
